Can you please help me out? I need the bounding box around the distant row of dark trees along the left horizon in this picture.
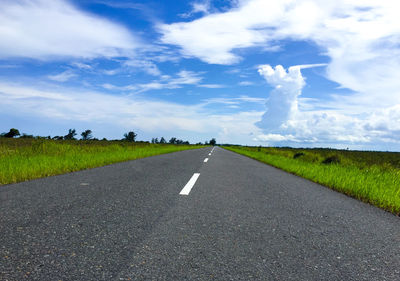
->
[0,128,217,145]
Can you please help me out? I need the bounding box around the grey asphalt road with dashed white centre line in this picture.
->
[0,147,400,281]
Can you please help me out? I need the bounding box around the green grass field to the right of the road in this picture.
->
[225,146,400,215]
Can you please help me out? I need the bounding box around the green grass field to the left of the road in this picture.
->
[0,138,199,184]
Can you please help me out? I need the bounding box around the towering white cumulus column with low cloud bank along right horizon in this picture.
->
[254,65,400,145]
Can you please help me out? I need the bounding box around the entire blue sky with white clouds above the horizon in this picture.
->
[0,0,400,151]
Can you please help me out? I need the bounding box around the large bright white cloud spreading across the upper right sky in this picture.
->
[159,0,400,105]
